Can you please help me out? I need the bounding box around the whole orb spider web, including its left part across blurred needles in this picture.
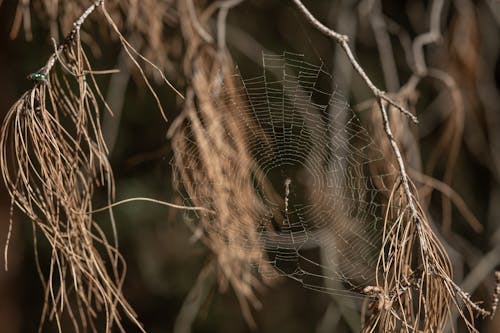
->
[173,53,394,295]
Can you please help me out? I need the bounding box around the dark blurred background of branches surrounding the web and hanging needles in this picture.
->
[0,0,500,333]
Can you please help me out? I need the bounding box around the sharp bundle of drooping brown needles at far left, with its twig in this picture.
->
[0,1,140,332]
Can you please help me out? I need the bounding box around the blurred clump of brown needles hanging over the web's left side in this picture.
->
[169,4,276,323]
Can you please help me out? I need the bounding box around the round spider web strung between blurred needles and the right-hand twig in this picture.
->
[174,52,394,296]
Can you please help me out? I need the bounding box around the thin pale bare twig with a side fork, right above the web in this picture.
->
[293,0,420,215]
